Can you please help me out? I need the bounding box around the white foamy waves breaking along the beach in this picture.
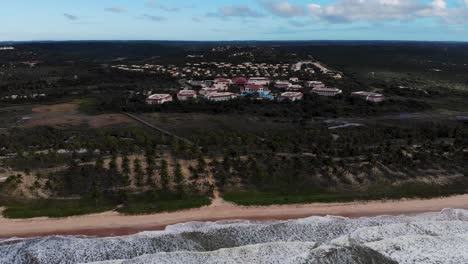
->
[0,209,468,264]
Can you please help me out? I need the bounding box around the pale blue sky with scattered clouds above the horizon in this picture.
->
[0,0,468,41]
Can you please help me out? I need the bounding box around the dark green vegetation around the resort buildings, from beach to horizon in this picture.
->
[0,42,468,218]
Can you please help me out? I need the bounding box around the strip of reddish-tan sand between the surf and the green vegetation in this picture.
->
[0,194,468,239]
